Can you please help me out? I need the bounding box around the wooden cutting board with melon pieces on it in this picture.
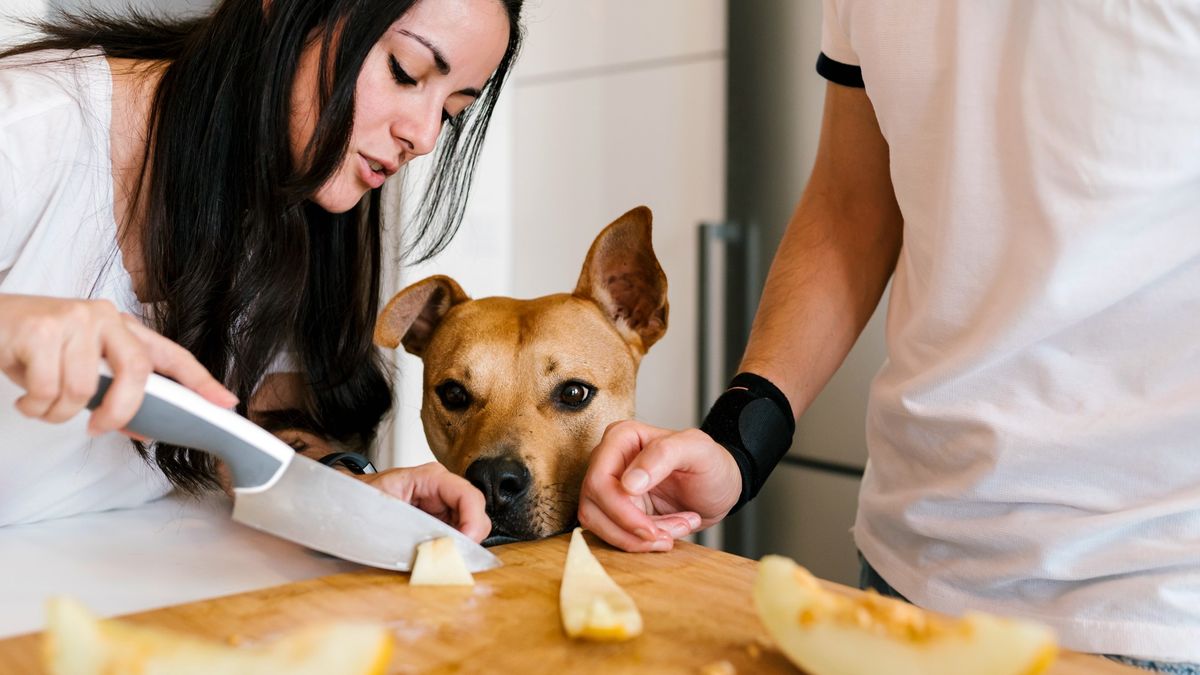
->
[0,536,1139,675]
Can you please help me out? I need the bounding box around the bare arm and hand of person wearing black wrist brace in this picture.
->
[578,84,902,551]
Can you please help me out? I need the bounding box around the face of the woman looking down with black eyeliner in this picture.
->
[289,0,509,213]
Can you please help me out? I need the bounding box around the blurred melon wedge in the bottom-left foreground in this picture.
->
[42,598,392,675]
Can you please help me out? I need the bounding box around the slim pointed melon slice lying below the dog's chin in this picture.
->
[558,527,642,641]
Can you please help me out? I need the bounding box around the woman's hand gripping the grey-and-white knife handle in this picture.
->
[0,294,238,435]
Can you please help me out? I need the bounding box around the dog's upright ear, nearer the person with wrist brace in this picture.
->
[575,207,668,353]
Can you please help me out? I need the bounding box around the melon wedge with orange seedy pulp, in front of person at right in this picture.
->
[754,556,1057,675]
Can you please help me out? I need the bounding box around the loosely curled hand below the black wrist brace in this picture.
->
[580,420,742,551]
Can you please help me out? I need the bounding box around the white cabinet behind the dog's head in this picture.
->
[395,0,726,465]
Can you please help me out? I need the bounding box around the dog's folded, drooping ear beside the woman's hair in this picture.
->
[374,274,470,356]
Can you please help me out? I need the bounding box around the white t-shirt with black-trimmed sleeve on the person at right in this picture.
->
[822,0,1200,662]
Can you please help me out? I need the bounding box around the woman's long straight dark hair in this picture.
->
[0,0,522,491]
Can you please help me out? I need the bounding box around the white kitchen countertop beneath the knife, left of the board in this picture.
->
[0,485,362,638]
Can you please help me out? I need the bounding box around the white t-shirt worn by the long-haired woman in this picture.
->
[0,52,170,526]
